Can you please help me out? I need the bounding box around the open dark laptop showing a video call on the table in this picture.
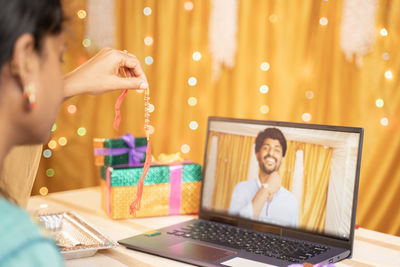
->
[119,117,363,266]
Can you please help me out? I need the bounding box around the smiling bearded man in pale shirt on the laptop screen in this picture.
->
[229,128,298,227]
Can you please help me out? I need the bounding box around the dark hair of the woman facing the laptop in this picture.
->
[0,0,64,67]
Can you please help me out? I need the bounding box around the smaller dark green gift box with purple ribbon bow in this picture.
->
[93,134,147,166]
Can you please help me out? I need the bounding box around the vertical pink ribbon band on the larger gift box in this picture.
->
[168,165,182,215]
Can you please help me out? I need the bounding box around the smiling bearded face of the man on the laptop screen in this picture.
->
[256,138,283,174]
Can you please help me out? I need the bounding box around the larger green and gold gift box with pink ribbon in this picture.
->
[100,162,202,219]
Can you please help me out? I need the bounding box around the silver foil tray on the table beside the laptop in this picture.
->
[38,212,117,259]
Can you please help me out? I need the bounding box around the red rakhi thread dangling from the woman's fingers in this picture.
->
[114,68,152,216]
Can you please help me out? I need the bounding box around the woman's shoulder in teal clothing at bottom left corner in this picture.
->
[0,197,63,266]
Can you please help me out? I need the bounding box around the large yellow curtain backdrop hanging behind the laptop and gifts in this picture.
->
[33,0,400,238]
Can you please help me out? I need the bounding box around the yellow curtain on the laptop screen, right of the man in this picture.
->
[299,143,333,231]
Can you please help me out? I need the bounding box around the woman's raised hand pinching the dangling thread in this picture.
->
[64,48,148,98]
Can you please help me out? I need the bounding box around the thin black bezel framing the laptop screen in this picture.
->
[199,116,364,251]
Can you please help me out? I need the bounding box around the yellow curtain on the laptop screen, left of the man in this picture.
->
[211,132,255,210]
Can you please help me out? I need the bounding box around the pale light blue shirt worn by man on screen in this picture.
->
[229,178,299,227]
